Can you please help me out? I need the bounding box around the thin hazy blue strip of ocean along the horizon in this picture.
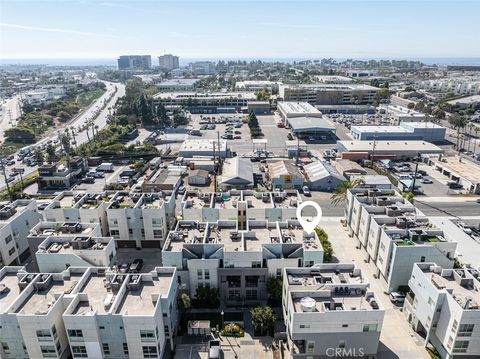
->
[0,53,480,68]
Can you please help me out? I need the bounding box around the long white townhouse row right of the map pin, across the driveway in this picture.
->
[345,188,457,292]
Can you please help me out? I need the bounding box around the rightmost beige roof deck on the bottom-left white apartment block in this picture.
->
[117,273,173,315]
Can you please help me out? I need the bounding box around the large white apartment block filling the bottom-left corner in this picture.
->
[0,267,178,359]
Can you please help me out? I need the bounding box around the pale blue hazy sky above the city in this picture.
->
[0,0,480,59]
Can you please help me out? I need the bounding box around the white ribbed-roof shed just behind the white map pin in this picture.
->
[303,161,347,191]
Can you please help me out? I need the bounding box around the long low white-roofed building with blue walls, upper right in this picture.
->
[350,122,447,142]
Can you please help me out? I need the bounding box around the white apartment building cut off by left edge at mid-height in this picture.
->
[0,200,42,267]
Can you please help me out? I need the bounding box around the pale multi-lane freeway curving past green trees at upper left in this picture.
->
[0,81,125,190]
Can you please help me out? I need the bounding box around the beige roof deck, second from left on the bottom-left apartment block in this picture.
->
[17,274,82,315]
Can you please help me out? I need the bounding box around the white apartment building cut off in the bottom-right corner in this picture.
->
[404,263,480,359]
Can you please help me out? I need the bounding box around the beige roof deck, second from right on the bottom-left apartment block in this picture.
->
[72,273,117,315]
